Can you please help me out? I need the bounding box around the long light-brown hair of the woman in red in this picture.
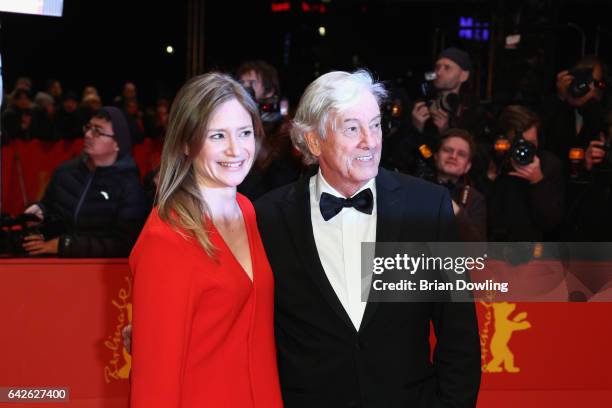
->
[156,72,263,256]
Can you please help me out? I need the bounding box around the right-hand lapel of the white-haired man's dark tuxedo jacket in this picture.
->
[359,168,404,332]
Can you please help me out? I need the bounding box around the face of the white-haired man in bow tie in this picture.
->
[307,92,382,197]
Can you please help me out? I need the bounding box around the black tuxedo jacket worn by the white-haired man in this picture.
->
[255,169,480,408]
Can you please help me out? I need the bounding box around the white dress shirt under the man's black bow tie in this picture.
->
[309,169,376,330]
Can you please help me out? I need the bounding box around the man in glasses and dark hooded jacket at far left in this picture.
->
[23,106,147,258]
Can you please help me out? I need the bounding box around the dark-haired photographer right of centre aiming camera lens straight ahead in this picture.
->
[486,105,564,241]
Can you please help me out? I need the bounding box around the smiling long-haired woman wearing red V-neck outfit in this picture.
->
[130,73,282,408]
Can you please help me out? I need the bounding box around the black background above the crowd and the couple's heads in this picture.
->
[0,0,612,103]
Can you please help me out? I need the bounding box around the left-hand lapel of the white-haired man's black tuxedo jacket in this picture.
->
[280,173,354,330]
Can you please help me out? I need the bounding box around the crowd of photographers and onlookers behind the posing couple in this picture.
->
[2,47,612,258]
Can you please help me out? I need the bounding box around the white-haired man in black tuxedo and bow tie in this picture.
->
[255,71,480,408]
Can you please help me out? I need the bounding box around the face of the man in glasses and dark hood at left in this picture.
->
[83,117,119,165]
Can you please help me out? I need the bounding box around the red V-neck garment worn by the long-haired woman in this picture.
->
[130,194,282,408]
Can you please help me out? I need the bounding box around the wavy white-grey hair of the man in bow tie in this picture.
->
[291,69,387,164]
